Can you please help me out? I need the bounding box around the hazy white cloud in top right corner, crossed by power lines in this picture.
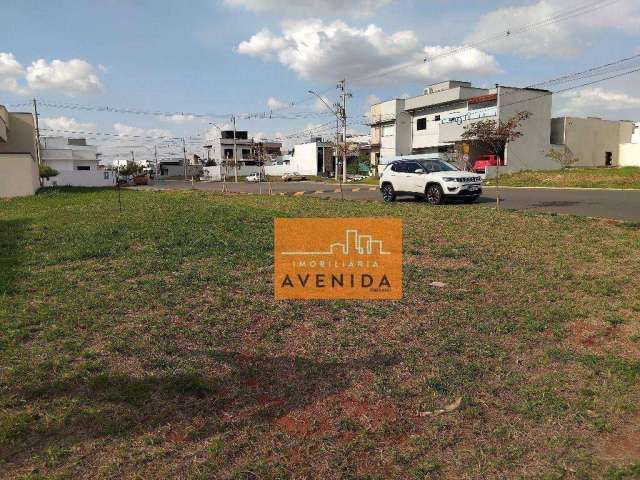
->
[466,0,640,57]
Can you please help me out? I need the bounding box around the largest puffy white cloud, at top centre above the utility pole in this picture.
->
[236,20,499,84]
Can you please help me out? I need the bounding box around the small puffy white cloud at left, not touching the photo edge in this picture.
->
[26,58,103,97]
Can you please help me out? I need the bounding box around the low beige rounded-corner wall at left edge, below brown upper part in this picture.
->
[0,153,40,198]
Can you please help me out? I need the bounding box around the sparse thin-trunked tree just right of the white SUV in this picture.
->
[462,112,531,206]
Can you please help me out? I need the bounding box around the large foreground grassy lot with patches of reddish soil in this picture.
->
[0,190,640,479]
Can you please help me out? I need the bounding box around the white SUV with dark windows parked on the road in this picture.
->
[380,159,482,205]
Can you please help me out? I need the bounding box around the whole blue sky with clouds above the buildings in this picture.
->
[0,0,640,161]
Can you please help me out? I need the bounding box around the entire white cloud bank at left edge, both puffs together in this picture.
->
[0,52,103,96]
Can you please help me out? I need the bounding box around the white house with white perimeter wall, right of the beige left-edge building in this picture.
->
[40,137,114,187]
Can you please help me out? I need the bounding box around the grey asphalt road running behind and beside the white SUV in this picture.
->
[141,180,640,221]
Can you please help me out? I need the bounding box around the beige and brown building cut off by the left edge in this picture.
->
[0,105,40,198]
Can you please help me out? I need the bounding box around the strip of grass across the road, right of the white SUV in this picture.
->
[487,167,640,188]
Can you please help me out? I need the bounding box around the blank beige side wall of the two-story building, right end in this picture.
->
[498,87,558,173]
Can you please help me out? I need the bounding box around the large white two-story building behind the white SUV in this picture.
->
[369,81,551,171]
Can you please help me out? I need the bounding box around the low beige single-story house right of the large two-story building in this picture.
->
[551,117,634,167]
